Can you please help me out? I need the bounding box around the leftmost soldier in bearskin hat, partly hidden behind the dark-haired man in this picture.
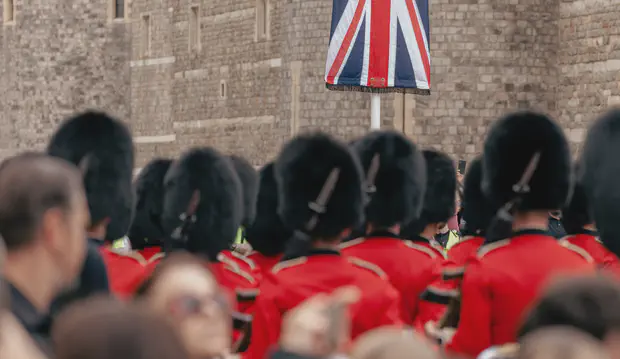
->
[47,112,143,295]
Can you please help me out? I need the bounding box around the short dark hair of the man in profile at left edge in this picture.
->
[0,152,82,252]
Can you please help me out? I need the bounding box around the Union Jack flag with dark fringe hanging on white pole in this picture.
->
[325,0,431,94]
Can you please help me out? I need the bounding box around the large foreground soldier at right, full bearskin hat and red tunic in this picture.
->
[444,112,594,357]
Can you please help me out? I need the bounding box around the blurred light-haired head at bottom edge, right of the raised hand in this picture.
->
[351,328,440,359]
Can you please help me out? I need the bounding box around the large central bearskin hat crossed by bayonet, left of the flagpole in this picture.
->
[274,133,365,238]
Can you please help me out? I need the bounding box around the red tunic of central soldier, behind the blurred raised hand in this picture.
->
[243,251,402,359]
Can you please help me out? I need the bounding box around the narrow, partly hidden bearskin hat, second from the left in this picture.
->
[129,158,172,249]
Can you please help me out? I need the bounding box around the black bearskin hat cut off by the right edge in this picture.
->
[578,109,620,255]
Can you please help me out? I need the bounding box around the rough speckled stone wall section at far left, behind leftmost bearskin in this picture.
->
[0,0,131,158]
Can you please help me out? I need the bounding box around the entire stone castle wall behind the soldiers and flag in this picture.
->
[0,0,620,167]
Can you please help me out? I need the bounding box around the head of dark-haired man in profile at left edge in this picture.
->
[0,153,89,294]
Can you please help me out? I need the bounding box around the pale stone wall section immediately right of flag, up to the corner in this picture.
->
[410,0,558,158]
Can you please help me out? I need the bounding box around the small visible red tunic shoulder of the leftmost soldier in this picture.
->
[99,246,147,298]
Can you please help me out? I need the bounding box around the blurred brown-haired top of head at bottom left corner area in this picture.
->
[52,298,188,359]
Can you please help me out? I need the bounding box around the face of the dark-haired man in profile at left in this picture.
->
[41,190,90,286]
